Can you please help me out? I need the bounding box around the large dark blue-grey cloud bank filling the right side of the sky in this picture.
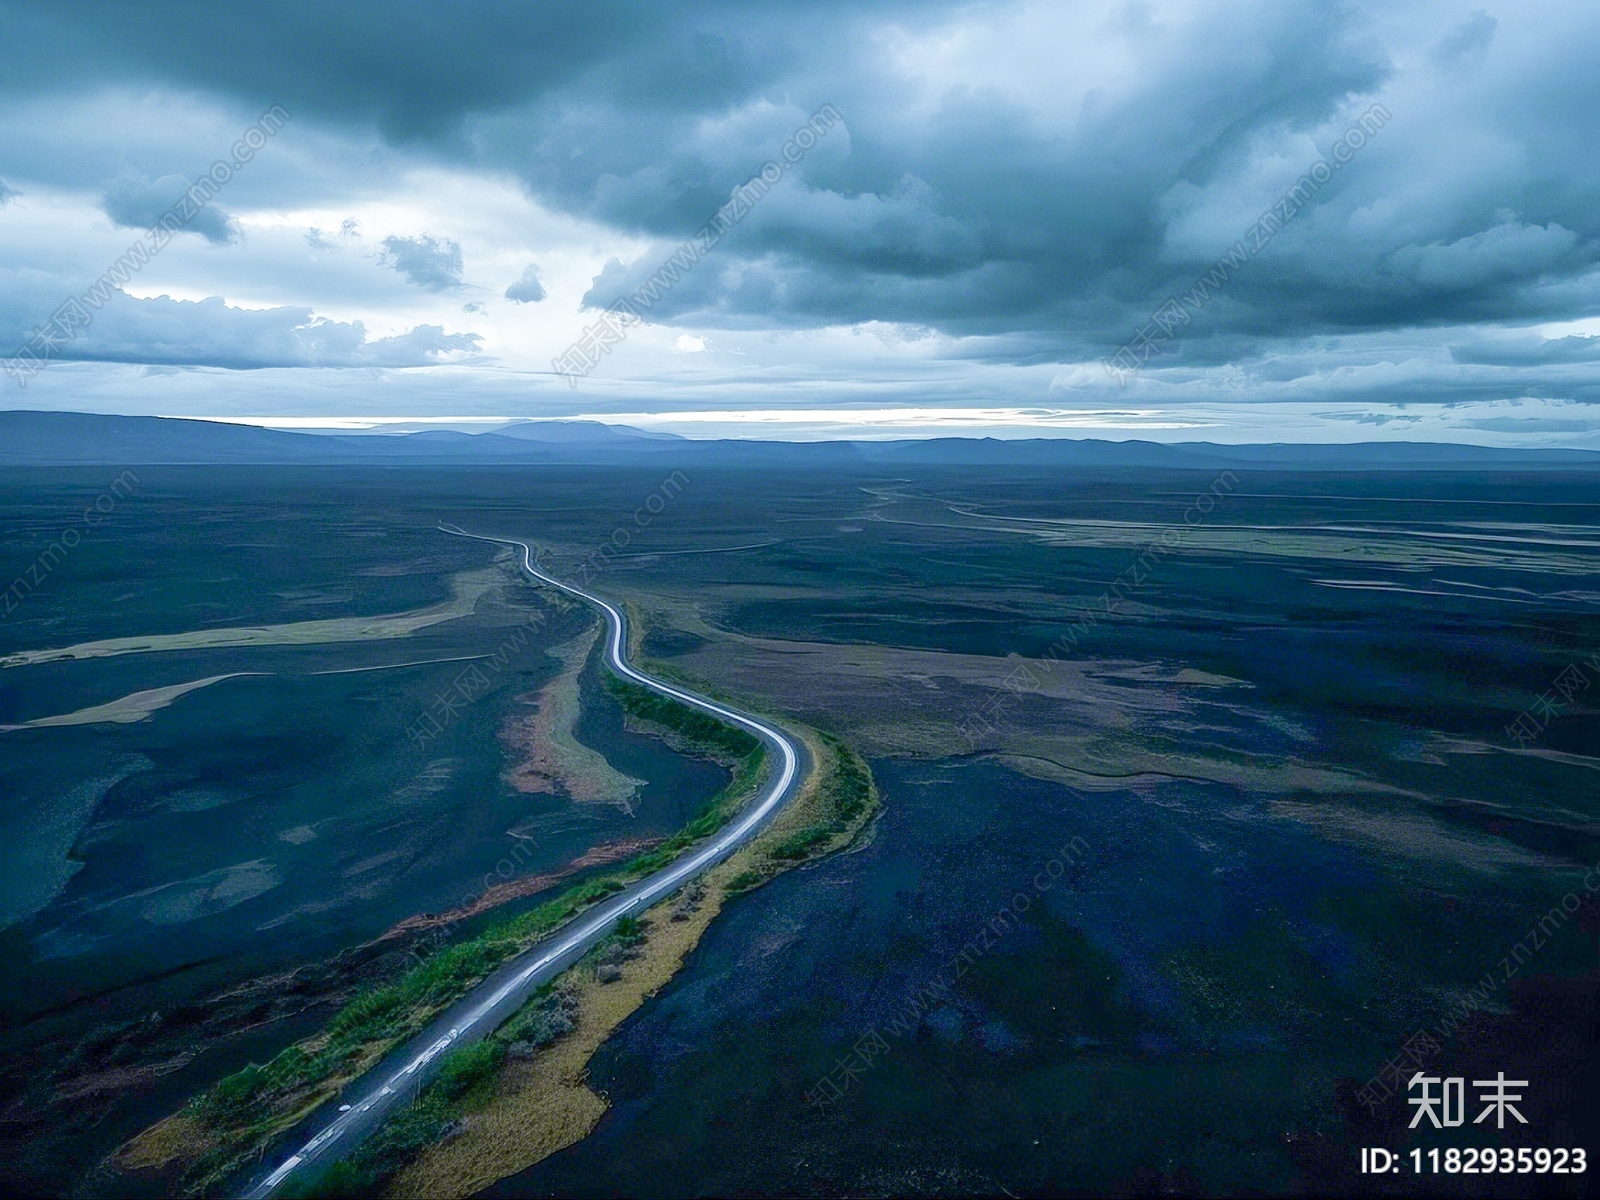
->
[486,3,1600,357]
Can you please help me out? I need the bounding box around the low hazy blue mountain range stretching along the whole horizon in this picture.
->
[0,411,1600,470]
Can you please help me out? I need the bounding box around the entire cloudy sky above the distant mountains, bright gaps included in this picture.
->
[0,0,1600,448]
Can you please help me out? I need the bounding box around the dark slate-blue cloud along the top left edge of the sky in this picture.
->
[0,0,761,141]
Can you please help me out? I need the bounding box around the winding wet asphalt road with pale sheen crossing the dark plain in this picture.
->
[245,525,810,1200]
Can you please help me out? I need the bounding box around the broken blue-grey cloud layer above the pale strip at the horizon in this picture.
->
[0,0,1600,441]
